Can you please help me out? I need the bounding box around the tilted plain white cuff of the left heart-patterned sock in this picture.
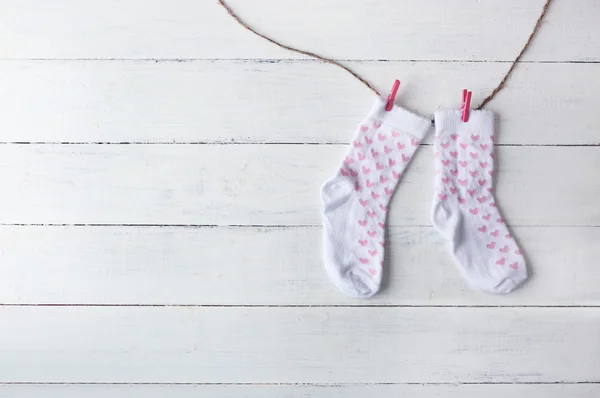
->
[368,98,431,141]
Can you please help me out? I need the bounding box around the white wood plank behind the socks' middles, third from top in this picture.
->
[0,145,600,226]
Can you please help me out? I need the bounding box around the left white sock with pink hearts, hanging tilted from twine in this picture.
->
[322,99,431,298]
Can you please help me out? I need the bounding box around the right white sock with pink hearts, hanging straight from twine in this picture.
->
[432,111,527,293]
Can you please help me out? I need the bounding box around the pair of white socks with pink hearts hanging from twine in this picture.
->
[322,99,527,298]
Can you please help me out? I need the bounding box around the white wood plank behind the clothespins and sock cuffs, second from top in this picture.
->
[0,60,600,145]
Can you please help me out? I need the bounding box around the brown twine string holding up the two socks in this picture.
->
[217,0,552,109]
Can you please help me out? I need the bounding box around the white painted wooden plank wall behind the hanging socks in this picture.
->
[0,0,600,398]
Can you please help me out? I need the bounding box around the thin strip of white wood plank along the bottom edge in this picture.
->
[0,384,600,398]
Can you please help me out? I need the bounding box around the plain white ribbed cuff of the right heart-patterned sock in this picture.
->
[435,110,494,137]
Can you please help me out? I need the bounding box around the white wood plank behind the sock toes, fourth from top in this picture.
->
[0,227,600,306]
